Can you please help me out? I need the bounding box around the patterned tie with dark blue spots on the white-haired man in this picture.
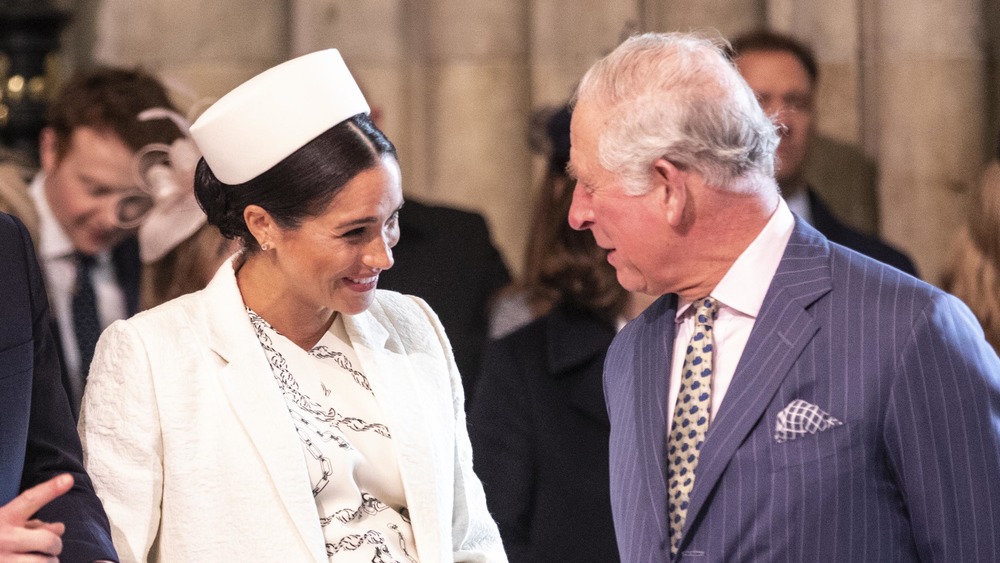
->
[667,297,719,554]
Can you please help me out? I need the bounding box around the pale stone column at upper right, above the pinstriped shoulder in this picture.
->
[862,0,989,282]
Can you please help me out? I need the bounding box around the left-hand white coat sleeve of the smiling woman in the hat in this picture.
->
[79,321,163,563]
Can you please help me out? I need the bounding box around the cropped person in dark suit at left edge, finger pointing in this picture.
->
[0,213,117,562]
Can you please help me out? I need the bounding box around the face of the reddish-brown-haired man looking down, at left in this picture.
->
[41,127,138,254]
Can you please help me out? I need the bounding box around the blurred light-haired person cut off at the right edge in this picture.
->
[941,138,1000,352]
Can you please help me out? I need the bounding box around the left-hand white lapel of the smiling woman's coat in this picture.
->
[202,259,327,561]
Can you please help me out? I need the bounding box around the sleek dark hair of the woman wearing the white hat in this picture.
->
[194,113,397,252]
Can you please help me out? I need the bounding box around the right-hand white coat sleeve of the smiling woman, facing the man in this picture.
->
[411,297,507,563]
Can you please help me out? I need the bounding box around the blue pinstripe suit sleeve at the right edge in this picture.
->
[884,294,1000,562]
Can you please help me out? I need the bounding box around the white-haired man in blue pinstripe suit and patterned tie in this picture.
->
[569,34,1000,562]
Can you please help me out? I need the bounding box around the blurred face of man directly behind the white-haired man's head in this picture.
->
[736,51,815,189]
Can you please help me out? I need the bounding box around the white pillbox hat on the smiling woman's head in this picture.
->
[191,49,370,184]
